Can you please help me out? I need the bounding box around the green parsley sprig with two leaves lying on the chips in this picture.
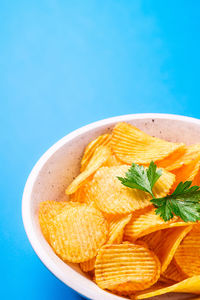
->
[118,161,200,222]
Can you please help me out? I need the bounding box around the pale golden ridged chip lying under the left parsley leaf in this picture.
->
[89,165,175,214]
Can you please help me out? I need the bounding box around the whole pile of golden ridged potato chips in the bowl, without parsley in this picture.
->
[39,123,200,299]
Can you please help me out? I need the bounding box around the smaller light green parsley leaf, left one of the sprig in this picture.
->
[117,161,162,198]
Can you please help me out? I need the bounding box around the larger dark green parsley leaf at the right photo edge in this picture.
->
[151,181,200,222]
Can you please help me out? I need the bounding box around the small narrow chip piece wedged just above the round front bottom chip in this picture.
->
[107,214,132,244]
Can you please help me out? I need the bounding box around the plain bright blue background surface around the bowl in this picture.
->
[0,0,200,300]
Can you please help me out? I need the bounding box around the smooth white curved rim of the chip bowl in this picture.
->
[22,113,200,300]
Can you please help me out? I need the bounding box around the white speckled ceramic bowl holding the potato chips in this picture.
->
[22,114,200,300]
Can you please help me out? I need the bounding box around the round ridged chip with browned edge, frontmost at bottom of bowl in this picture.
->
[95,243,160,293]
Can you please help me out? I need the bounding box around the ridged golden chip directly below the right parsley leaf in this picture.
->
[124,207,191,242]
